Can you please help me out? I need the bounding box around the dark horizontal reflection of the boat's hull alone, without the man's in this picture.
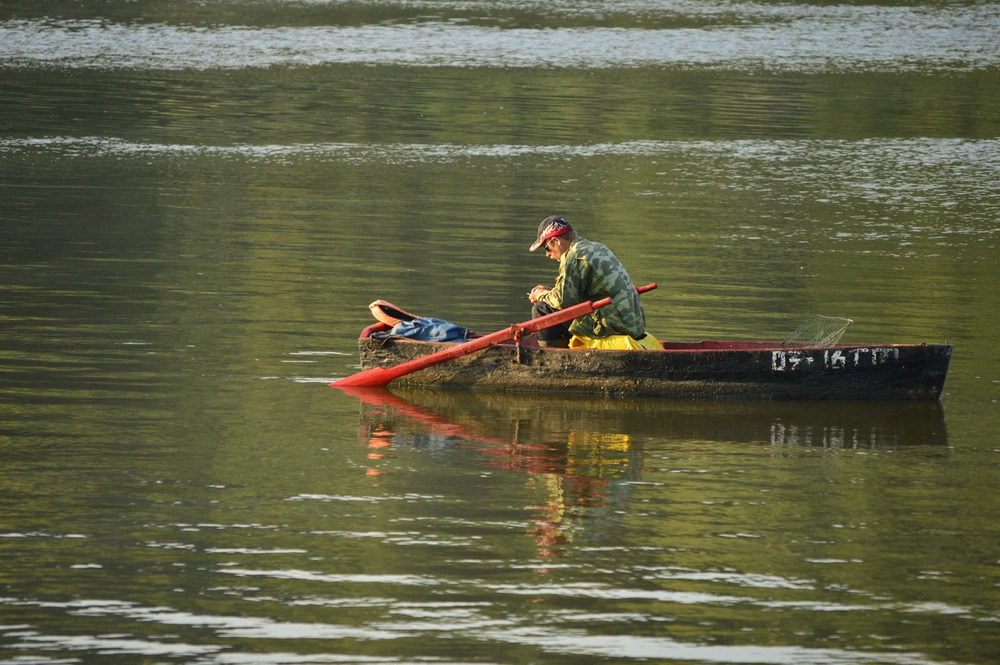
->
[345,387,948,454]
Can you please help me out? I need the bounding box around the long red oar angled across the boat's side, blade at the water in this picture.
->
[330,284,656,388]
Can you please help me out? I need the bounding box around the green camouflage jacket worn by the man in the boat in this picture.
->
[539,237,646,338]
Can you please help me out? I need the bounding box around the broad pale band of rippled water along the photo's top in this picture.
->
[0,9,1000,72]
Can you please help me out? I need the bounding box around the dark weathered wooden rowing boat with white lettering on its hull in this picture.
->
[358,323,952,400]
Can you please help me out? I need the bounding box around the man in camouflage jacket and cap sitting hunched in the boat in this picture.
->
[528,215,662,349]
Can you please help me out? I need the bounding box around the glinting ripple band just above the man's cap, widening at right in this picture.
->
[0,137,1000,226]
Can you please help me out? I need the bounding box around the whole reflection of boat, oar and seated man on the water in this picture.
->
[345,387,947,558]
